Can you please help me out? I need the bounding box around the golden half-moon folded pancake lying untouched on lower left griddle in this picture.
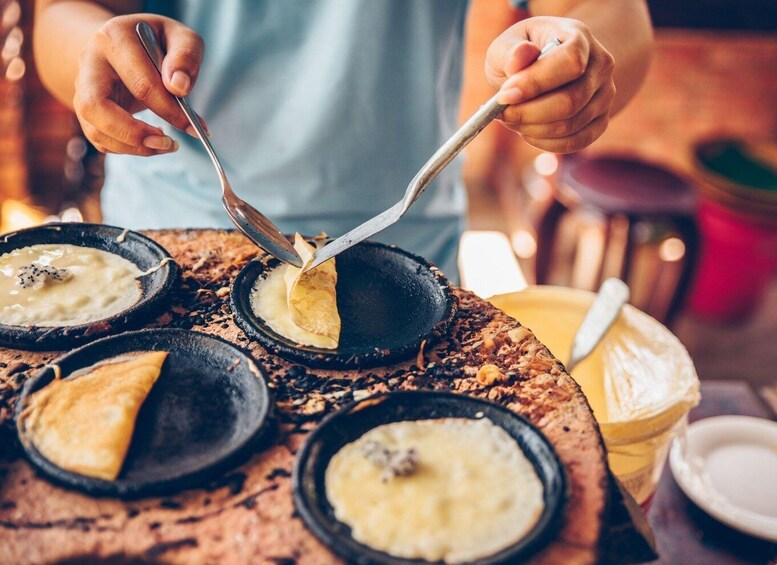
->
[21,351,167,480]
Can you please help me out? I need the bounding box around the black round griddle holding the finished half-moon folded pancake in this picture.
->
[16,329,272,498]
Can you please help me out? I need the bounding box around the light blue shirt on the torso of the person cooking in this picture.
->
[104,0,467,270]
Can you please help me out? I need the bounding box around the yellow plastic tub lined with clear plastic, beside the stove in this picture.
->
[489,286,699,504]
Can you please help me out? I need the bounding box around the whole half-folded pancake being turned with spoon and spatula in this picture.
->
[251,234,340,349]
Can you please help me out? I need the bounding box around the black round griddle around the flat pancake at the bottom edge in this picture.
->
[292,391,567,565]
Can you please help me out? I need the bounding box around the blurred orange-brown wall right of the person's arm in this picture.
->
[591,29,777,173]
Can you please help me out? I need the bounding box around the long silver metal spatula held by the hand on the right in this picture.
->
[306,39,561,270]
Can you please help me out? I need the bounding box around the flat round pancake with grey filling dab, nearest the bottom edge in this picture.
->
[325,418,544,563]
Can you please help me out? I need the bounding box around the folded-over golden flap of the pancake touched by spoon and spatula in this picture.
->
[284,234,340,349]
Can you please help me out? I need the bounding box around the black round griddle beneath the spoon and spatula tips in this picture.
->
[230,242,456,369]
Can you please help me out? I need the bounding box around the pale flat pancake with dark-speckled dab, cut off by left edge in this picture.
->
[0,244,142,326]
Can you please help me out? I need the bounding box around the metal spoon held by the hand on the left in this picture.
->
[135,22,302,267]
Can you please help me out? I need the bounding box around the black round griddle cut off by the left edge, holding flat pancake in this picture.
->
[0,223,180,351]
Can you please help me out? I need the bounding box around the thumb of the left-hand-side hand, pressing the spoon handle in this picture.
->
[162,20,205,96]
